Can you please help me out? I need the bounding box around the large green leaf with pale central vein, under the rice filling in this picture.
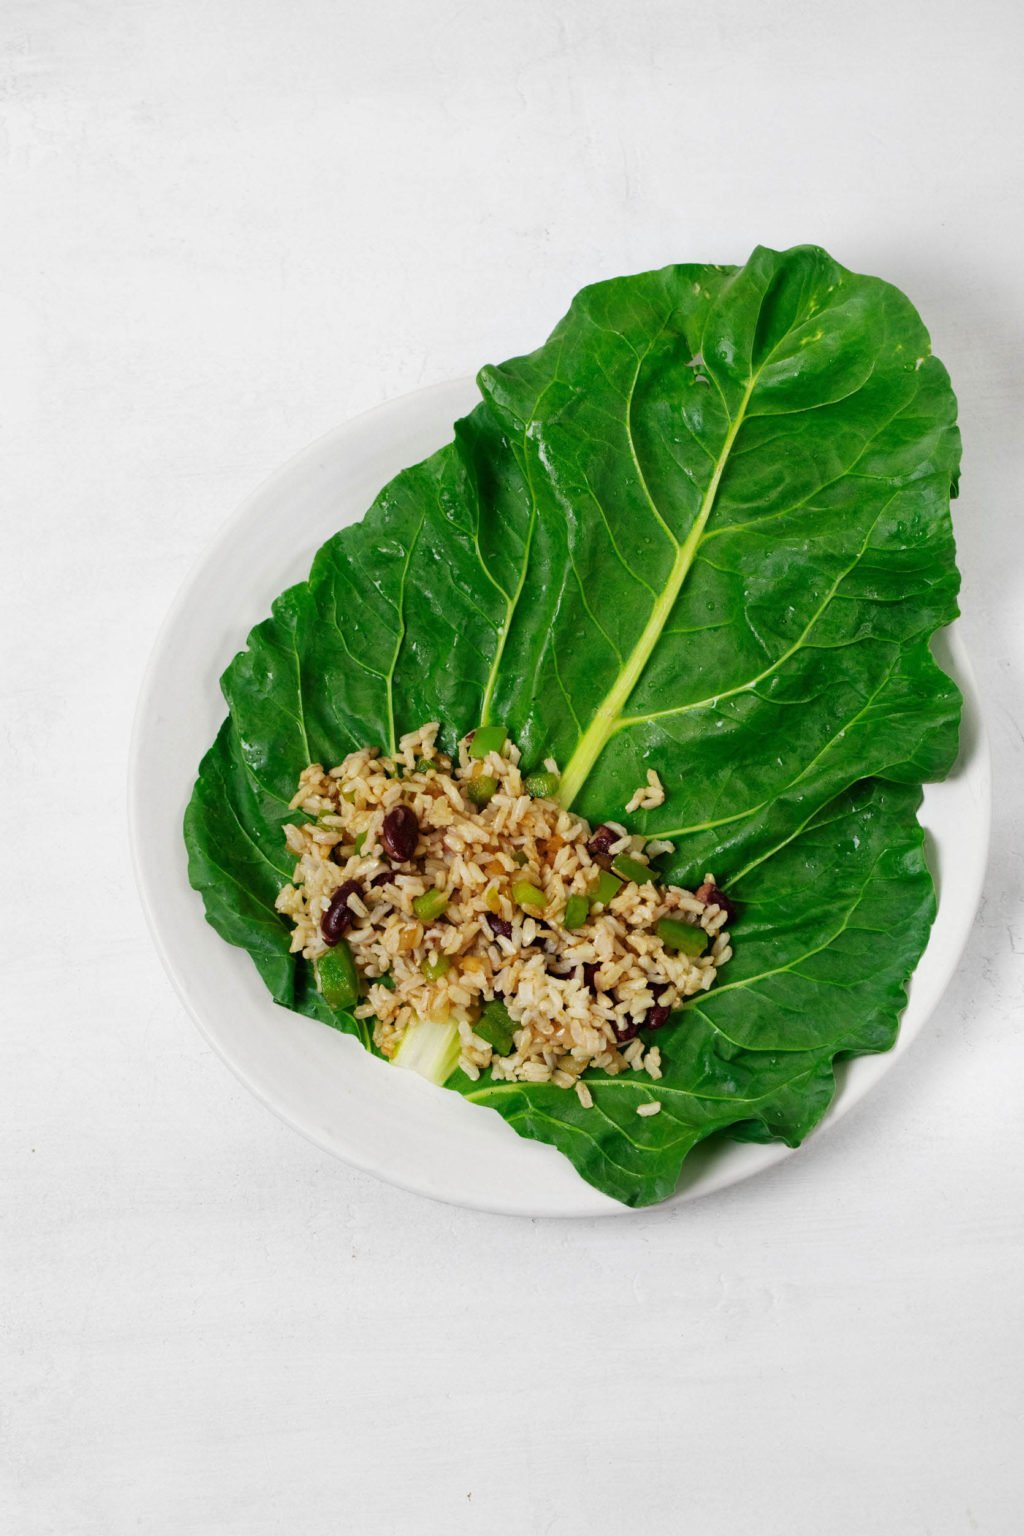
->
[186,247,960,1203]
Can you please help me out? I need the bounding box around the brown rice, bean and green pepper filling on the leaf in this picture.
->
[276,722,732,1114]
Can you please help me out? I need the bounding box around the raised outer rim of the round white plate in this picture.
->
[127,376,992,1218]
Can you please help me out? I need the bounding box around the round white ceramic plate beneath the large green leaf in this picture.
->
[129,379,990,1217]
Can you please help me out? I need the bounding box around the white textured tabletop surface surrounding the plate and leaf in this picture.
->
[0,0,1024,1536]
